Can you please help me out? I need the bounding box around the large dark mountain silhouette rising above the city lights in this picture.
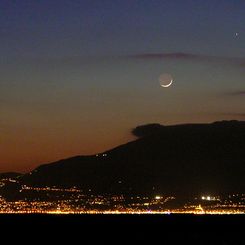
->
[20,121,245,195]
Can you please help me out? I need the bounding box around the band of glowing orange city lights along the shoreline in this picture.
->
[0,178,245,214]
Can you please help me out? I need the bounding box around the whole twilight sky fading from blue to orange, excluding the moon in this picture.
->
[0,0,245,172]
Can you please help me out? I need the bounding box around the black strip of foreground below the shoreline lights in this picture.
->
[0,214,245,244]
